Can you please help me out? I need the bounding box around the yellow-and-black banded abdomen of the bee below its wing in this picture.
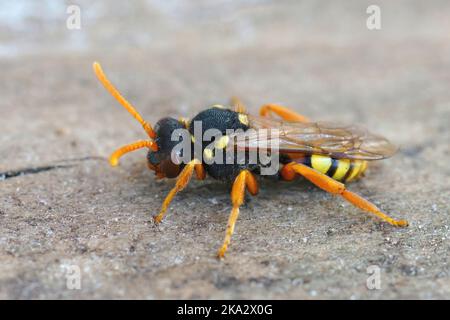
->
[303,154,367,182]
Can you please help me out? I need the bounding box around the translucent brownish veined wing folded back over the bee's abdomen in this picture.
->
[228,115,397,160]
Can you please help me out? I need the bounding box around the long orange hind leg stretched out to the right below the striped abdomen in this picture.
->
[283,162,408,227]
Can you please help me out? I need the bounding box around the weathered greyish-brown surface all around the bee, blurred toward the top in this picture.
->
[0,0,450,299]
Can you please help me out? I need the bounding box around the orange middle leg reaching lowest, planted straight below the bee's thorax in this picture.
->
[217,170,258,258]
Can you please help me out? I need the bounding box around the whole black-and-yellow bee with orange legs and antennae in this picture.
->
[93,63,408,258]
